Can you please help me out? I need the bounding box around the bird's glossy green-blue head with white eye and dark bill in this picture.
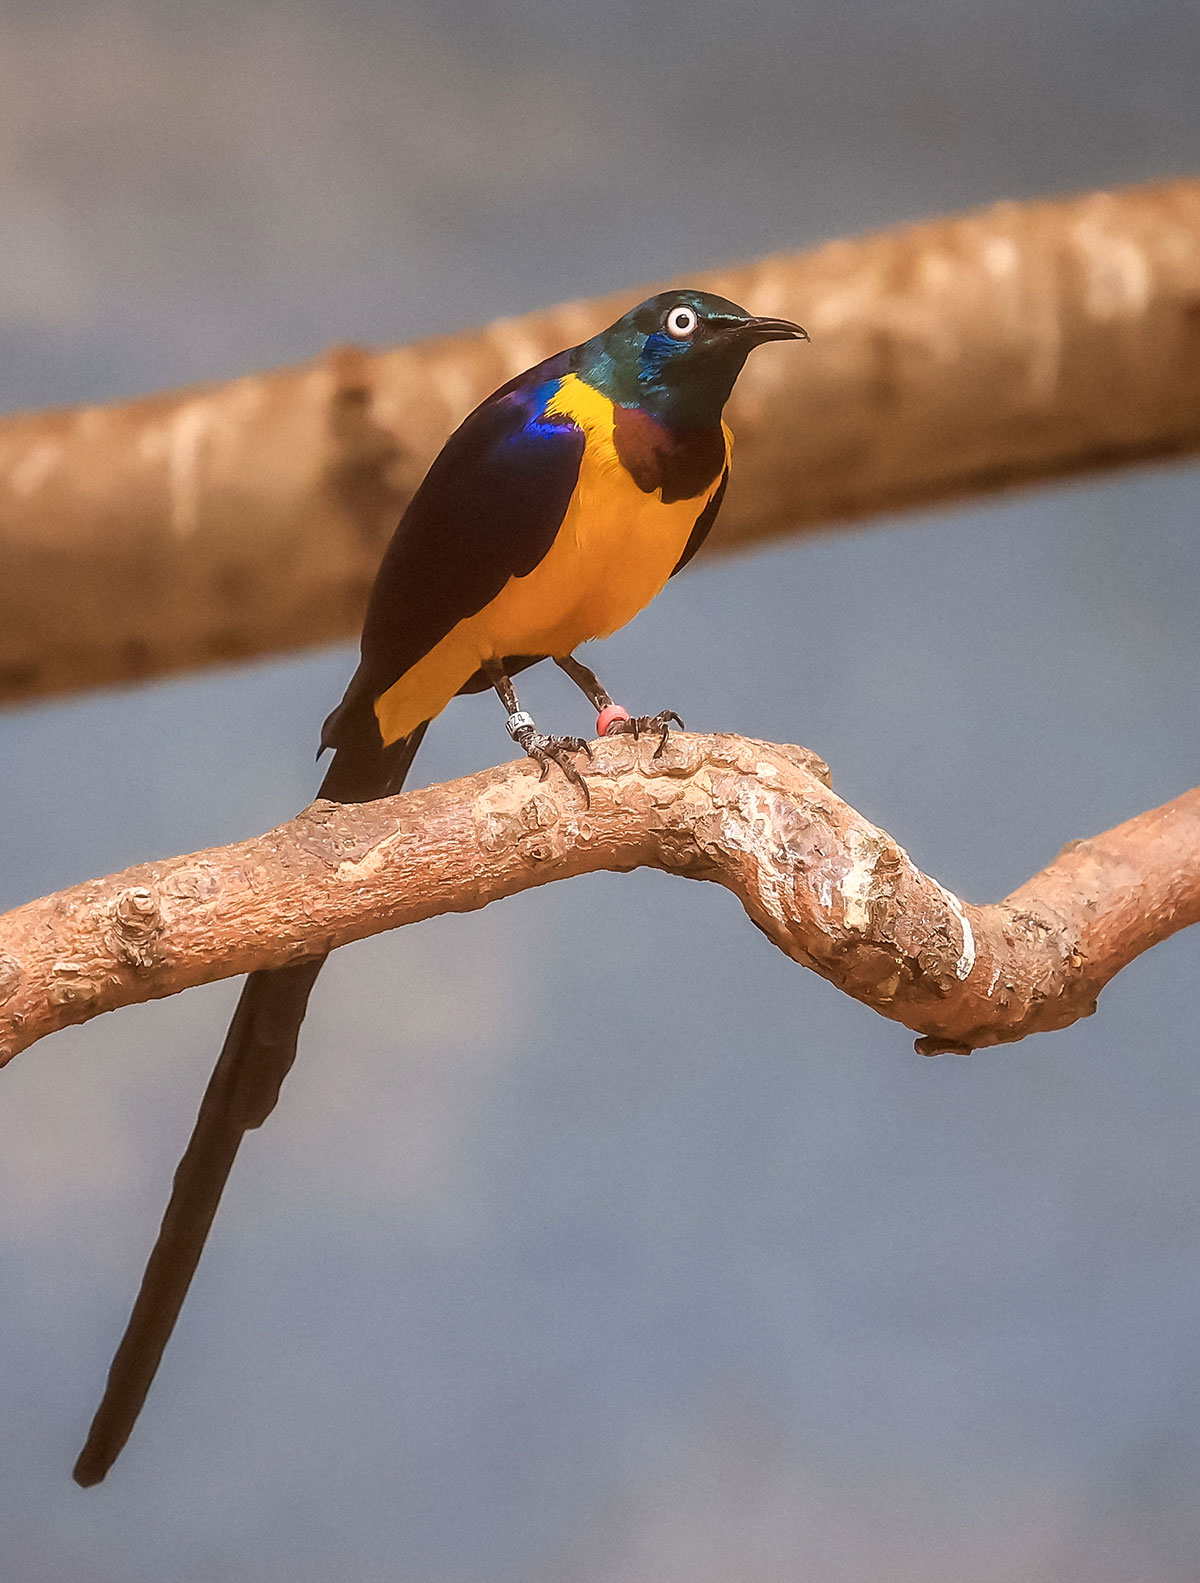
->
[575,291,809,427]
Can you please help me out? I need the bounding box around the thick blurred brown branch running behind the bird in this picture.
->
[0,180,1200,701]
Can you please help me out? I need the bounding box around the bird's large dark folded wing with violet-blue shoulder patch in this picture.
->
[361,351,586,697]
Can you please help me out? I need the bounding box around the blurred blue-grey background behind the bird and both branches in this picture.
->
[0,0,1200,1583]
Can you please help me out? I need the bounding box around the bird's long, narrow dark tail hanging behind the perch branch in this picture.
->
[74,699,426,1486]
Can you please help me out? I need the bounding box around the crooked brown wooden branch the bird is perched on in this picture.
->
[0,733,1200,1061]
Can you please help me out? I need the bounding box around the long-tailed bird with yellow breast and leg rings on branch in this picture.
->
[74,290,809,1486]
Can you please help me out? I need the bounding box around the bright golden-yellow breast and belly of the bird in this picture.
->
[375,374,731,742]
